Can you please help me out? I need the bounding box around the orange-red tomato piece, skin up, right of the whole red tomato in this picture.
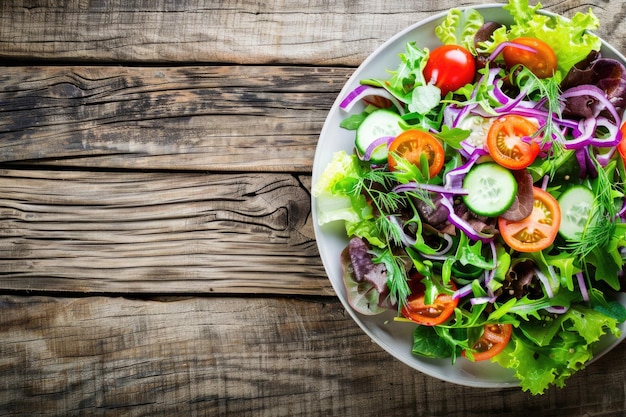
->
[502,38,557,78]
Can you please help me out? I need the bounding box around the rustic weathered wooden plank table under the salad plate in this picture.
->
[0,0,626,417]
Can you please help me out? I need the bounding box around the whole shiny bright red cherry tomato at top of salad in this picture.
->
[424,45,476,96]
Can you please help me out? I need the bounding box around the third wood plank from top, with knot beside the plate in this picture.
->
[0,170,332,294]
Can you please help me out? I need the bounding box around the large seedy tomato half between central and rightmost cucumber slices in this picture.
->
[498,187,561,252]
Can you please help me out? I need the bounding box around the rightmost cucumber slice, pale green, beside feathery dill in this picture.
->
[557,185,595,240]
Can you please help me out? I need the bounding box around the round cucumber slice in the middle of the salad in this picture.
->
[463,162,517,217]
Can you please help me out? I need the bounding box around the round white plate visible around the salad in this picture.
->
[312,4,626,388]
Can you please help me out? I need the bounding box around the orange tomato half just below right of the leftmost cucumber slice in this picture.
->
[387,129,445,178]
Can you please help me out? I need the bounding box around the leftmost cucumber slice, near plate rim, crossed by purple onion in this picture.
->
[355,109,403,164]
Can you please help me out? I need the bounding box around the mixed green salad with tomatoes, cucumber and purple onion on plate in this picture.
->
[313,0,626,394]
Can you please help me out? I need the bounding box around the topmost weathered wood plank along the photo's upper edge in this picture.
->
[0,0,626,66]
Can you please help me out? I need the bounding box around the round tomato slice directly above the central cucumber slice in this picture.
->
[485,115,541,170]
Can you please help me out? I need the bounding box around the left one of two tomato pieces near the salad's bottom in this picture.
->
[401,278,459,326]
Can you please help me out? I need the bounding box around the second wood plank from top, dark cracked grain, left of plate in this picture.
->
[0,66,352,172]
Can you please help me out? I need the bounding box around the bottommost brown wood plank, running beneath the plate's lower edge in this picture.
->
[0,296,626,417]
